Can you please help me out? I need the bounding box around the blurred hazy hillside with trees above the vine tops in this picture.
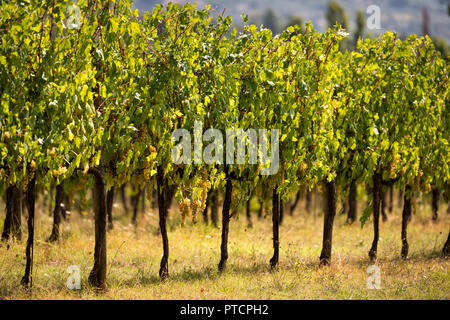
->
[134,0,450,57]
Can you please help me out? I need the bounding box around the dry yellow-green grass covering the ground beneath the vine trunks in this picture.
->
[0,192,450,299]
